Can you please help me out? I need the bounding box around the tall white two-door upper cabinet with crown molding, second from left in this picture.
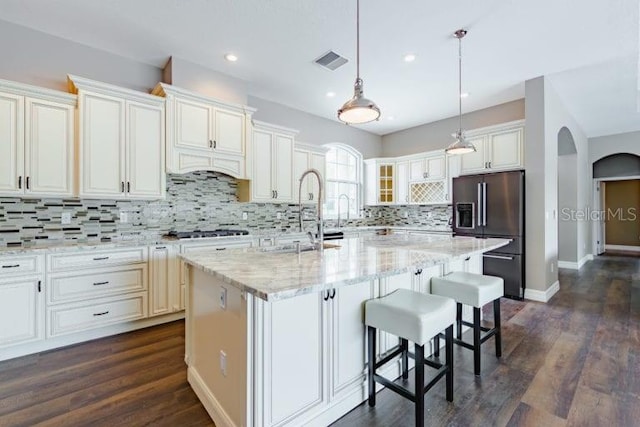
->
[69,76,166,199]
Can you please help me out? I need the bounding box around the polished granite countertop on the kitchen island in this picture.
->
[180,234,510,301]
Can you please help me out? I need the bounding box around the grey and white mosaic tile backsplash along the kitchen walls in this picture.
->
[0,171,451,246]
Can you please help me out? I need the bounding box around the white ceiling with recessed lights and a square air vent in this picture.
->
[0,0,640,136]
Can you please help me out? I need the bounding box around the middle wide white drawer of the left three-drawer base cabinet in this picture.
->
[47,264,147,304]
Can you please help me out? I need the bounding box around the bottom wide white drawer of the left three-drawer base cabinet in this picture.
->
[47,292,147,338]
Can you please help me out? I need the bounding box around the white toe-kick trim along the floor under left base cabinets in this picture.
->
[0,311,184,361]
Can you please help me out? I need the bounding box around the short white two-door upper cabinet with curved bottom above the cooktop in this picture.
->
[152,83,255,179]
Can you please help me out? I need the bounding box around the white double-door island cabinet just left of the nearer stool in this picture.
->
[256,281,377,426]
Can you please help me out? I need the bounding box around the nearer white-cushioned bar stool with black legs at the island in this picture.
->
[365,289,456,427]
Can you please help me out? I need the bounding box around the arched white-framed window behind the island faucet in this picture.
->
[325,144,362,219]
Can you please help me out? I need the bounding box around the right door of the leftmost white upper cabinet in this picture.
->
[25,98,75,196]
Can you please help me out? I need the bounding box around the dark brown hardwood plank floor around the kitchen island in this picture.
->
[0,256,640,427]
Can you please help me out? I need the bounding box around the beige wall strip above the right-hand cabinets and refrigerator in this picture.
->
[382,99,524,157]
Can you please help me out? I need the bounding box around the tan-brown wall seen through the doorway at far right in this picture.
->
[605,179,640,246]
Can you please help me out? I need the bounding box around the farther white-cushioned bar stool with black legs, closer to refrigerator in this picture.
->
[431,271,504,375]
